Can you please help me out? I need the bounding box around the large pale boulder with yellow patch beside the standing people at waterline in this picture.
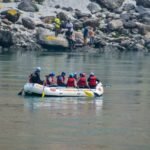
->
[37,29,69,48]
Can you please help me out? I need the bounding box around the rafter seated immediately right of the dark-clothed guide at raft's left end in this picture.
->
[46,72,56,86]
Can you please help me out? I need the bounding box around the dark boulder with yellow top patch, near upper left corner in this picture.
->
[1,9,20,23]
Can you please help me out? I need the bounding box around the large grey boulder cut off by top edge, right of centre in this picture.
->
[95,0,124,10]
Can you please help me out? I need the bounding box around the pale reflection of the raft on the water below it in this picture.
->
[25,97,103,113]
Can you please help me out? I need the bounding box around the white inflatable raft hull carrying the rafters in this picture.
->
[24,83,104,97]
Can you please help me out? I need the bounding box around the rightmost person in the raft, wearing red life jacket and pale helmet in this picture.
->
[87,72,99,88]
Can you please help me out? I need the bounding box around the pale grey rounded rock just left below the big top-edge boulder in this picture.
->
[87,2,102,14]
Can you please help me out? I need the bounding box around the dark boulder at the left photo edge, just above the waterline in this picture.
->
[0,30,13,47]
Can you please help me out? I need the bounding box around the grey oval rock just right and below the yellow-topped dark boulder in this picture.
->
[22,17,35,30]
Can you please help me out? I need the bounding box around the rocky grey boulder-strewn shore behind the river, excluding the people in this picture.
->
[0,0,150,52]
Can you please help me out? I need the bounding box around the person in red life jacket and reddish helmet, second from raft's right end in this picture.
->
[77,73,88,88]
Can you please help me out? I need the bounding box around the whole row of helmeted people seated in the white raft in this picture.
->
[29,67,100,88]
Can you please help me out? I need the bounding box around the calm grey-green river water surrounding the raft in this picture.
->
[0,52,150,150]
